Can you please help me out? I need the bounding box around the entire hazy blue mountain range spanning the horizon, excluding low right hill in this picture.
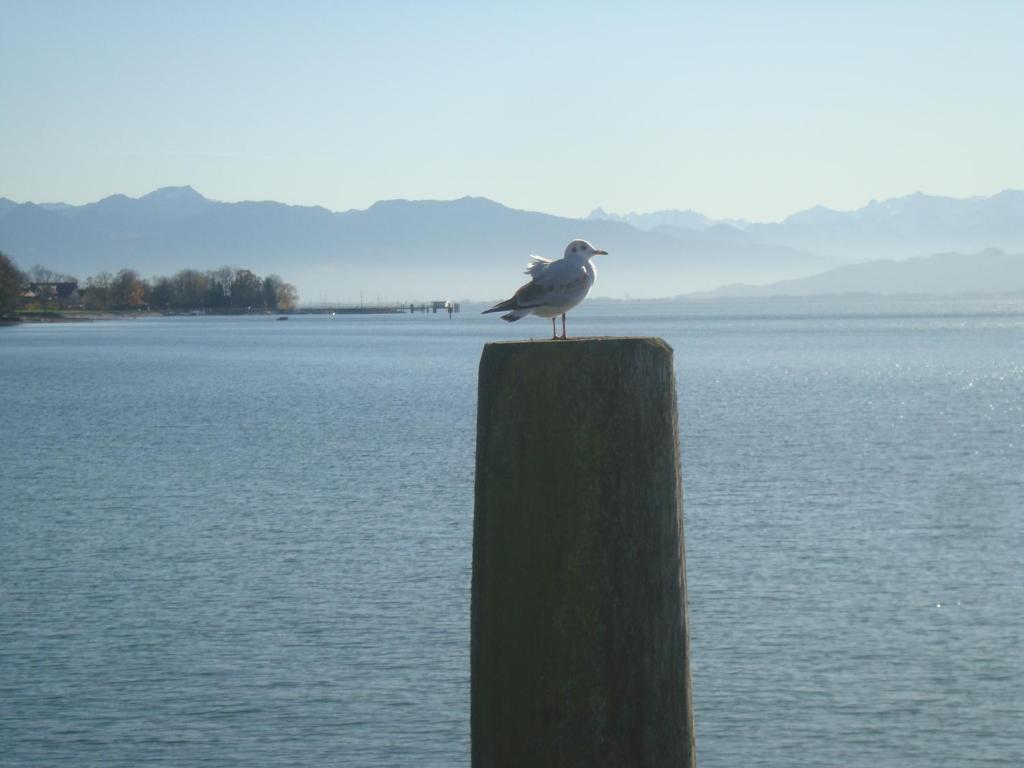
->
[0,186,1024,302]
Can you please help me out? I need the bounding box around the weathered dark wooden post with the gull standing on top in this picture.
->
[471,338,695,768]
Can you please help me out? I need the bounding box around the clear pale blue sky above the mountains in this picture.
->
[0,0,1024,220]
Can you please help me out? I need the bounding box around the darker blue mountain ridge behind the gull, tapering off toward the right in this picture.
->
[0,186,836,301]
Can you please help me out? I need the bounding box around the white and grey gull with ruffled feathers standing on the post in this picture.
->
[482,240,607,339]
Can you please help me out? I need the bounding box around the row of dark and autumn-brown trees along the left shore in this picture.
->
[0,253,299,315]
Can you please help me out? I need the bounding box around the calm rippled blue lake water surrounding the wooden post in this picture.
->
[0,301,1024,768]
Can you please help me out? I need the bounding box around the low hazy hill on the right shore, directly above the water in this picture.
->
[702,248,1024,296]
